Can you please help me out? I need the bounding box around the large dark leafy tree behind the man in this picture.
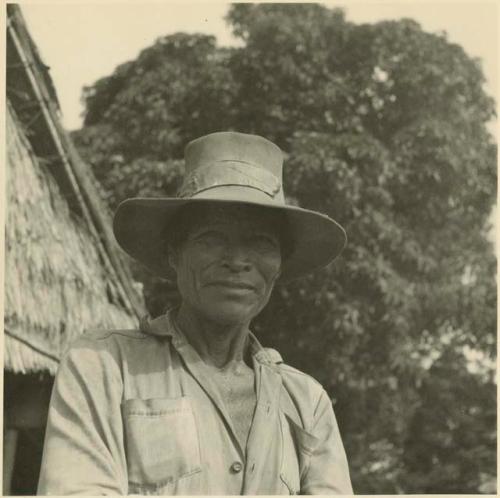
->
[74,4,496,493]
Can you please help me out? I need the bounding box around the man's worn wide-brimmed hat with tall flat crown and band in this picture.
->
[113,132,347,280]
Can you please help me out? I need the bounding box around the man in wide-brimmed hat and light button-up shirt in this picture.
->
[39,132,352,495]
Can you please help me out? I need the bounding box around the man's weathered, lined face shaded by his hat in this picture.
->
[169,207,281,325]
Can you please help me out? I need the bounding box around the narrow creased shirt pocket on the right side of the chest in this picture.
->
[280,415,319,495]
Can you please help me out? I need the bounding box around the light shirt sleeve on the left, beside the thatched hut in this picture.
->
[38,337,127,495]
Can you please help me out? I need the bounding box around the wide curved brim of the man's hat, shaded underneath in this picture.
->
[113,197,347,281]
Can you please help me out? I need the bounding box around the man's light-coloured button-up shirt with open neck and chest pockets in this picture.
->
[38,314,352,495]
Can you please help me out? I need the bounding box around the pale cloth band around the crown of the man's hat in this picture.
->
[178,160,283,198]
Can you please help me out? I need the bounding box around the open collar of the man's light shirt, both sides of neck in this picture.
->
[139,309,283,365]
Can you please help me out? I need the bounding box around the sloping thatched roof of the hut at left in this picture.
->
[4,5,143,373]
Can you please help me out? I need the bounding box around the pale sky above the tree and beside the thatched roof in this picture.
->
[17,0,498,130]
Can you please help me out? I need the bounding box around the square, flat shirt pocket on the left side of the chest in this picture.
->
[122,397,201,494]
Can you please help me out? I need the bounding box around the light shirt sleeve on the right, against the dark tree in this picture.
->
[301,390,353,495]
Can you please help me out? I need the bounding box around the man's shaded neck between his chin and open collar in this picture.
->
[175,305,254,369]
